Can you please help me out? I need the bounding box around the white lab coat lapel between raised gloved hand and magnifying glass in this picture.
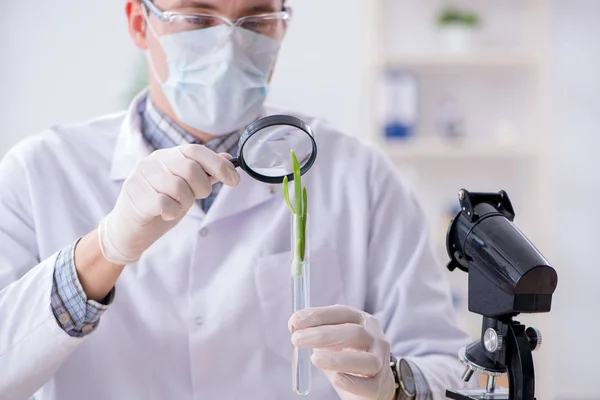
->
[203,171,280,226]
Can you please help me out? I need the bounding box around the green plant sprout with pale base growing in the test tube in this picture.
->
[283,150,308,277]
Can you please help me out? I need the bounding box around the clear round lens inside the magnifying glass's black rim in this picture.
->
[243,125,314,178]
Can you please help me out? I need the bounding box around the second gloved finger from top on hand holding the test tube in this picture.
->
[292,324,373,351]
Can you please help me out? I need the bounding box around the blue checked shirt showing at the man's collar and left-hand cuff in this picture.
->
[50,97,242,337]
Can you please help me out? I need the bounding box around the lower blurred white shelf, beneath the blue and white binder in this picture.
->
[380,138,536,161]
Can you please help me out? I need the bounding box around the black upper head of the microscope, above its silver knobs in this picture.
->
[446,189,558,317]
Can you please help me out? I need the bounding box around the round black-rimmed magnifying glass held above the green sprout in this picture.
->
[230,115,317,183]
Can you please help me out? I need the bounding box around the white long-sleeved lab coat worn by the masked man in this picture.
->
[0,92,468,400]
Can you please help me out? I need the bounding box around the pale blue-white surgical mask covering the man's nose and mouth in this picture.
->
[146,20,280,136]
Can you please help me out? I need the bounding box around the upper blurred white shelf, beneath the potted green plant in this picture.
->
[383,52,539,69]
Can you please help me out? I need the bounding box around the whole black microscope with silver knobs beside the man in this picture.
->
[446,189,558,400]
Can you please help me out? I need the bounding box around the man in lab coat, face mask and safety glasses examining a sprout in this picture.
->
[0,0,468,400]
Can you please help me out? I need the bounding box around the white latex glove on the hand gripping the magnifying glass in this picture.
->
[98,144,240,265]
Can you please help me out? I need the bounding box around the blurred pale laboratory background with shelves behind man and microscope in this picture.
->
[0,0,600,400]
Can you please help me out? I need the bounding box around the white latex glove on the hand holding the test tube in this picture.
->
[288,305,396,400]
